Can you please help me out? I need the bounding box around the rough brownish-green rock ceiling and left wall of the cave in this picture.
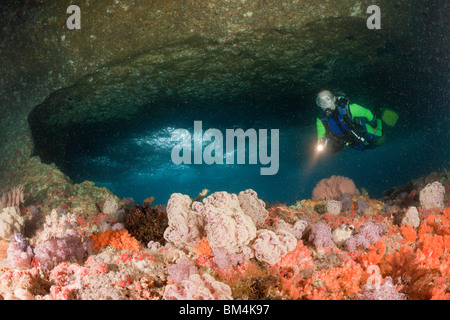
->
[0,0,447,200]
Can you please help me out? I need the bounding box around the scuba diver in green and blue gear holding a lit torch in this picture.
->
[316,90,384,152]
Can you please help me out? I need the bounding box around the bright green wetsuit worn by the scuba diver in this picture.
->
[316,103,383,150]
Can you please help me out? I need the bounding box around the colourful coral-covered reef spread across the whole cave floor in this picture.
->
[0,172,450,300]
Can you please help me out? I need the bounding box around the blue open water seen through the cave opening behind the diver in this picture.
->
[66,90,450,204]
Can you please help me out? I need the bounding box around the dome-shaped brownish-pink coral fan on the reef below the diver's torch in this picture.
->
[312,176,359,200]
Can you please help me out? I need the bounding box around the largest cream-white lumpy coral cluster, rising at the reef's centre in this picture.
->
[164,189,268,253]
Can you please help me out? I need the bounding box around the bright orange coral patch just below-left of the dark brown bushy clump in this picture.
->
[91,229,140,251]
